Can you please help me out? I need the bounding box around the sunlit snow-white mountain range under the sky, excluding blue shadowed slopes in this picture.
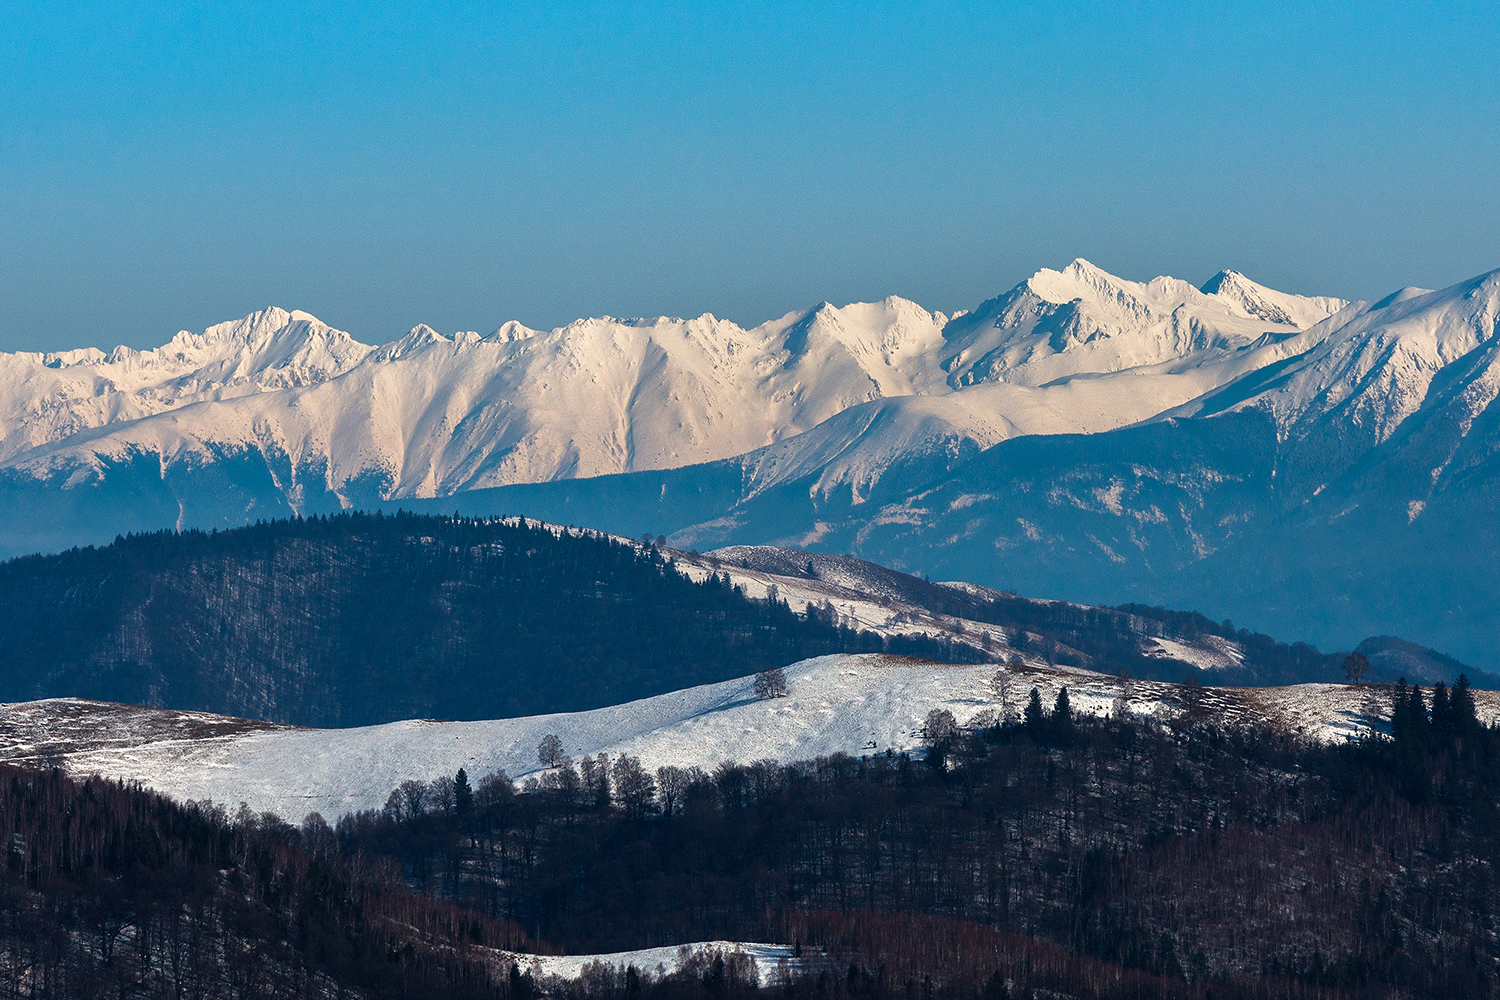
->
[0,261,1341,510]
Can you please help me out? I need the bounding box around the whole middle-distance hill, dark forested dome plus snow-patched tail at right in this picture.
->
[0,514,1392,726]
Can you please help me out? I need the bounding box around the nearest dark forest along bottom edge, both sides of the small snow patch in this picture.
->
[0,768,1346,1000]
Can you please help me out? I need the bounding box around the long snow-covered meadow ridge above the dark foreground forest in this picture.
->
[0,654,1500,822]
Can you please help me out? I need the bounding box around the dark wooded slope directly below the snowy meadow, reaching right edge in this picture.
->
[338,685,1500,997]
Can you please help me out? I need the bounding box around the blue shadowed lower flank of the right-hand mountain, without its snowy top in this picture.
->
[375,392,1500,670]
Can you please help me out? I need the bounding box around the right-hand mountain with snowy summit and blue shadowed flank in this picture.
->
[396,273,1500,673]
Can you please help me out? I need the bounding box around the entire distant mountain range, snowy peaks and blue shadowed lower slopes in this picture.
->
[0,259,1500,670]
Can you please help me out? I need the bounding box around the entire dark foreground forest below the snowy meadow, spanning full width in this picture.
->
[11,685,1500,1000]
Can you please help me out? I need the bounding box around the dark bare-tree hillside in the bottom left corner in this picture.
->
[0,768,530,1000]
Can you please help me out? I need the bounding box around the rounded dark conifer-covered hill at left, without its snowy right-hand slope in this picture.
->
[0,514,980,726]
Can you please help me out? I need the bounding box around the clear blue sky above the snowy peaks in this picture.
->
[0,3,1500,349]
